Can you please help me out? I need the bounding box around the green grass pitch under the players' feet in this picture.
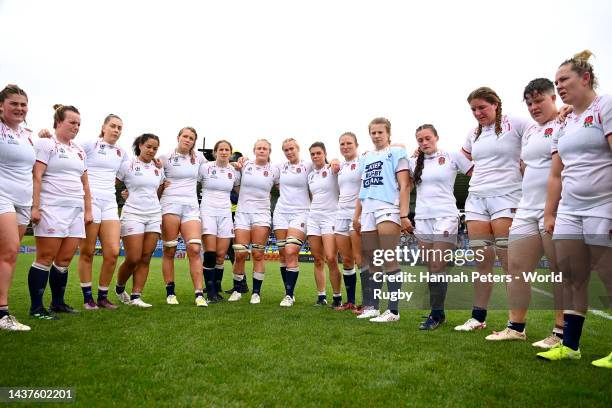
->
[0,254,612,407]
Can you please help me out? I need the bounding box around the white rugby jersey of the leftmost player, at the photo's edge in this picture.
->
[0,121,36,207]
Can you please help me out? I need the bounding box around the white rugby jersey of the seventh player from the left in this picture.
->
[236,160,279,213]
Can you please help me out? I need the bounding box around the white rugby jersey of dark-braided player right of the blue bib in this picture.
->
[409,150,473,220]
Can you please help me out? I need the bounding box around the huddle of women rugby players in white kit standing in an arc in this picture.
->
[0,51,612,368]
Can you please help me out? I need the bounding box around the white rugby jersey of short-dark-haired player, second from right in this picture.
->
[518,118,561,210]
